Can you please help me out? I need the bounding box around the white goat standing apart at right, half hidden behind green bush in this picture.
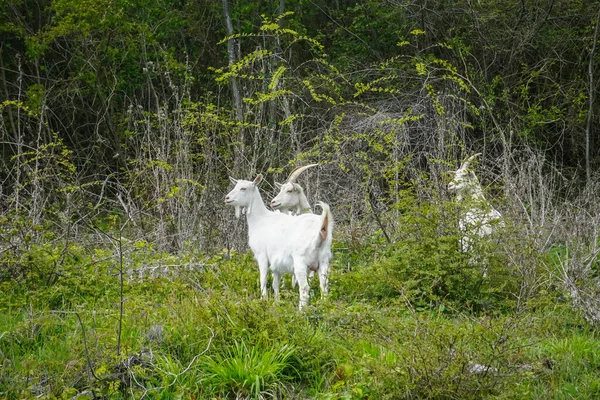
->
[448,153,502,252]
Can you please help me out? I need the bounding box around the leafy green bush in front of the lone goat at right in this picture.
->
[332,196,525,312]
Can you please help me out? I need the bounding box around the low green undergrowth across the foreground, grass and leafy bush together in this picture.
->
[0,214,600,399]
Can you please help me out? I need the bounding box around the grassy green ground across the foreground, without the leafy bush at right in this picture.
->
[0,244,600,399]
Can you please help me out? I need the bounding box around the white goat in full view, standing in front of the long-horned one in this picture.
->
[225,175,333,309]
